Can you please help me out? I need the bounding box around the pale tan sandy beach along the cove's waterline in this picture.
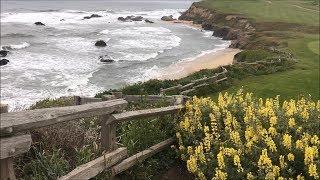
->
[158,20,241,79]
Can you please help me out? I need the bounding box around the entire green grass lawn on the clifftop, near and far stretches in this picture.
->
[202,0,320,99]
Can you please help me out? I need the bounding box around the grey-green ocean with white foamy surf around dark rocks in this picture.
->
[1,0,230,111]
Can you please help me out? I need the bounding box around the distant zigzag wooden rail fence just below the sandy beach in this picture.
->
[160,67,228,95]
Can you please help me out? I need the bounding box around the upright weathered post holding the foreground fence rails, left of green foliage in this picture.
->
[100,115,117,152]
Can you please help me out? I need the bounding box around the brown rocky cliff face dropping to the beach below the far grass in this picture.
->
[179,2,255,49]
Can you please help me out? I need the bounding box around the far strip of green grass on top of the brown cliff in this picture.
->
[201,0,319,26]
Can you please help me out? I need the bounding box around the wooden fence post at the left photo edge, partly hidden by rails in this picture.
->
[0,104,16,180]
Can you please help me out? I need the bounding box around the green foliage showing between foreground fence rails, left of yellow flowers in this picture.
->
[117,99,179,179]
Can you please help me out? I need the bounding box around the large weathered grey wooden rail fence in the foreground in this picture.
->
[0,95,185,180]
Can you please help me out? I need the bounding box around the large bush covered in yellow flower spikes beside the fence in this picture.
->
[176,90,320,179]
